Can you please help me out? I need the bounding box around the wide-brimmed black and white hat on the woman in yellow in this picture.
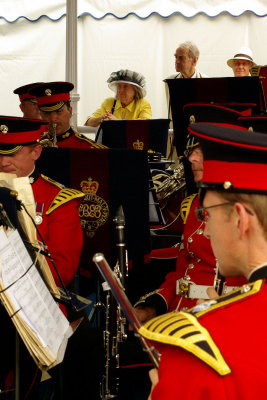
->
[107,69,146,97]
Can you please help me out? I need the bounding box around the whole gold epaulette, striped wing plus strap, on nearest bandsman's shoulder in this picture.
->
[139,280,263,375]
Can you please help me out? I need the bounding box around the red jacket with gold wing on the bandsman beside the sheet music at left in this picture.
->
[32,172,84,287]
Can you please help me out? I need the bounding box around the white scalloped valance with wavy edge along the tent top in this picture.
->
[0,0,267,23]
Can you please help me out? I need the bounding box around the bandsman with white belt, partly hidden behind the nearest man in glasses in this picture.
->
[135,136,246,322]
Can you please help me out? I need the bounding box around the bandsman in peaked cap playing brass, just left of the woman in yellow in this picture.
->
[29,82,106,149]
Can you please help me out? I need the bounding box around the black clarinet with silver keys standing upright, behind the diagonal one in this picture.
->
[100,206,128,400]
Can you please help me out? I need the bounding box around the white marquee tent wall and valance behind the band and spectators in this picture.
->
[0,0,267,125]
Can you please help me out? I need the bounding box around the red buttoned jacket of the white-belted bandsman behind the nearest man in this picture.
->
[135,194,247,315]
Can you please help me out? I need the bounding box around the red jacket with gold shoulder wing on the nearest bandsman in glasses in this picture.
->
[140,267,267,400]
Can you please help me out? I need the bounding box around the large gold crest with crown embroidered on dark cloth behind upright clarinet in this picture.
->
[79,177,109,238]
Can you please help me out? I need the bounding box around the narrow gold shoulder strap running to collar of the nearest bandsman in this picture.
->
[192,279,263,318]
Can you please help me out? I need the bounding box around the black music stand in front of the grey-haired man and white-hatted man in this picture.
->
[166,77,266,155]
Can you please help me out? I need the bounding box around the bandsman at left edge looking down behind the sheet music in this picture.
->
[0,117,84,286]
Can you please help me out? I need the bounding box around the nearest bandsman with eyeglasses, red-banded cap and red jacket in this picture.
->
[140,124,267,400]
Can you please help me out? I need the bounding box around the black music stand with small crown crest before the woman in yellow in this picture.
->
[96,119,170,157]
